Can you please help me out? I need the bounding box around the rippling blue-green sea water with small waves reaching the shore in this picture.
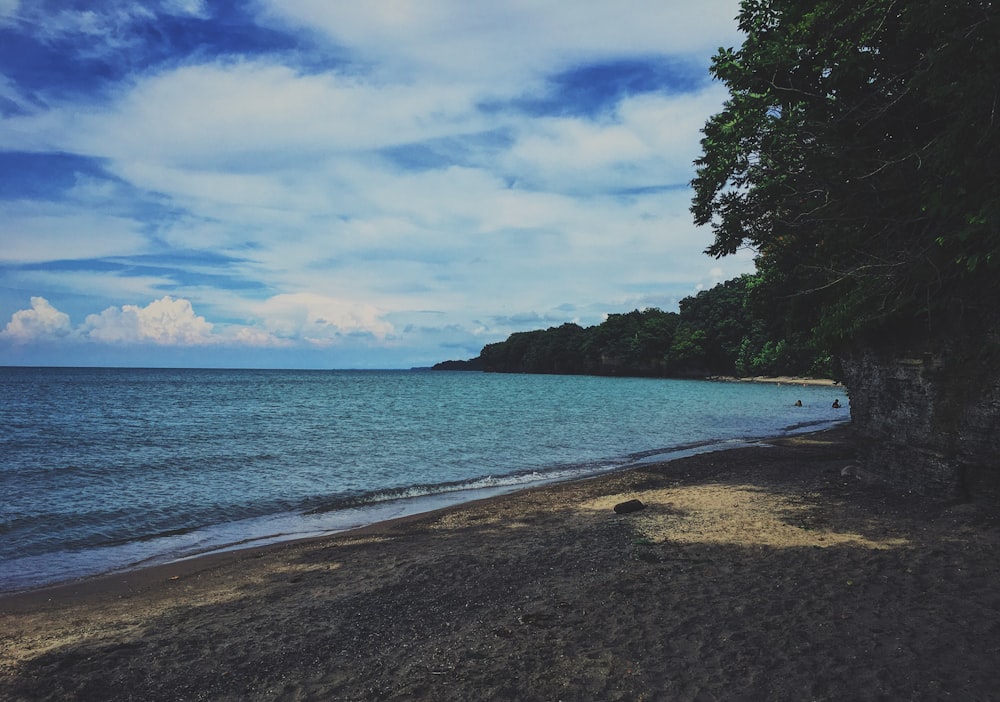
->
[0,368,848,591]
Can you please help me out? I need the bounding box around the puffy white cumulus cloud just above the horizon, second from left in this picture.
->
[83,295,217,346]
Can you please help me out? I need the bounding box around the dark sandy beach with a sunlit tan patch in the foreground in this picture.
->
[0,428,1000,702]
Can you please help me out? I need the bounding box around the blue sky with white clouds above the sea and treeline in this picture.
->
[0,0,753,368]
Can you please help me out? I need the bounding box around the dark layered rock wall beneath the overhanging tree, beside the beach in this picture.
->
[842,339,1000,500]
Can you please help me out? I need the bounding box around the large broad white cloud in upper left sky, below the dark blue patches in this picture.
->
[65,59,484,173]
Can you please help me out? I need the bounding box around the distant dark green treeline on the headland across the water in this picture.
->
[434,275,833,377]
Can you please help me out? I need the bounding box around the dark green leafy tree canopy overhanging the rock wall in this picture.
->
[692,0,1000,341]
